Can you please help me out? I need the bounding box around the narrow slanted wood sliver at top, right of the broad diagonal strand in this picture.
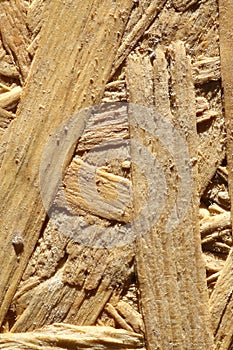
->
[111,0,166,76]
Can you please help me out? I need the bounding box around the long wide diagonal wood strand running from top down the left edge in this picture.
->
[0,0,133,323]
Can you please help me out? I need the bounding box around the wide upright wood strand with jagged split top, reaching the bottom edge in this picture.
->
[126,42,213,349]
